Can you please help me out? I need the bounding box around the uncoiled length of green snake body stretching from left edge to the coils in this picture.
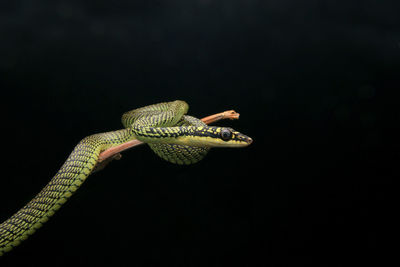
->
[0,129,133,256]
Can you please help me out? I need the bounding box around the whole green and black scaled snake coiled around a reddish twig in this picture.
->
[0,100,252,256]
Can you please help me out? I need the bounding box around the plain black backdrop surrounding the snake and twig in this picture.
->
[0,0,400,267]
